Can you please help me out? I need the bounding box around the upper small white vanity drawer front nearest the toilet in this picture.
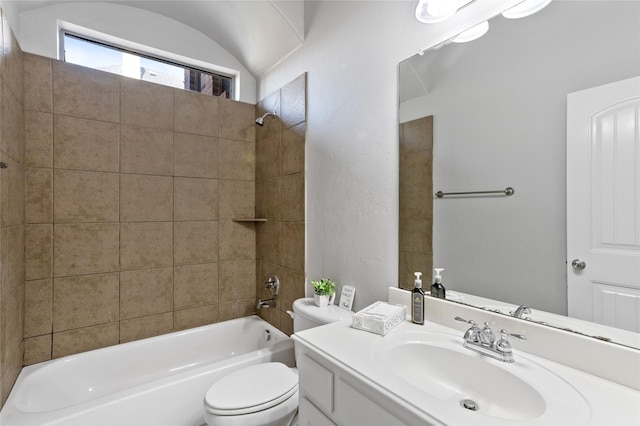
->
[298,354,333,414]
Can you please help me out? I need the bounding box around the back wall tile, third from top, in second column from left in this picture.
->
[53,169,120,223]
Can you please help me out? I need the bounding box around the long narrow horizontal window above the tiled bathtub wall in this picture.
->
[63,32,233,99]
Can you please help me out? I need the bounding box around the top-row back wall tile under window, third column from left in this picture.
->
[120,77,174,130]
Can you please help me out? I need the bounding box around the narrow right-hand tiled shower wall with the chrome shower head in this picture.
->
[256,74,306,334]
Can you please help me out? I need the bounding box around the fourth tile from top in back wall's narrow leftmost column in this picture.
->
[25,224,53,280]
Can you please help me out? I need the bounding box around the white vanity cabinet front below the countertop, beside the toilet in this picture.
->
[296,341,426,426]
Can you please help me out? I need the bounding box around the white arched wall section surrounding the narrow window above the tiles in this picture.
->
[13,2,256,104]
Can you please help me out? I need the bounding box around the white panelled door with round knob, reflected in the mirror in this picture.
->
[567,77,640,331]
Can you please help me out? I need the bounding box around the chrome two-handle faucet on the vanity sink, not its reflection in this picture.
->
[455,317,527,362]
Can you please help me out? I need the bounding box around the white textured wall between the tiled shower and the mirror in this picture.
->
[258,1,517,310]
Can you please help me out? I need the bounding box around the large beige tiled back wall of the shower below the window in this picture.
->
[24,54,256,365]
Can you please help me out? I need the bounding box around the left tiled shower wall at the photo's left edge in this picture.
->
[0,11,24,407]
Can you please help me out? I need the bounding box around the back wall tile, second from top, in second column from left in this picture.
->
[53,114,120,172]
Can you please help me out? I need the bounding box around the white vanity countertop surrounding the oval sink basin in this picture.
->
[294,320,640,425]
